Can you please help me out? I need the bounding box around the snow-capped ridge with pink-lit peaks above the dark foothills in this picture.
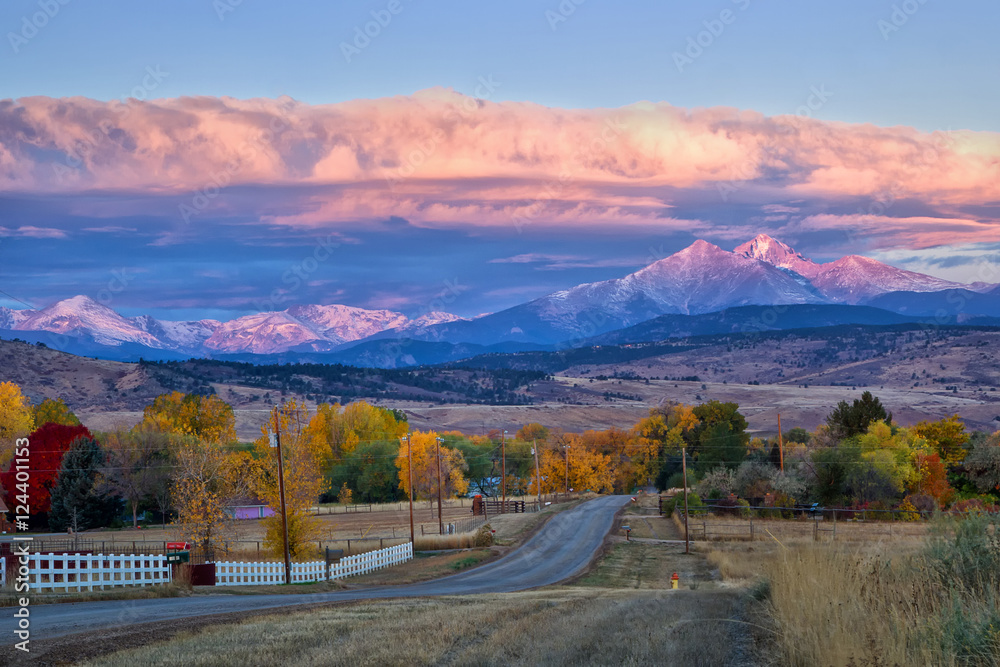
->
[0,234,1000,355]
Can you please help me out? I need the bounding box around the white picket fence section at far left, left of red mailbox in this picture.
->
[28,553,170,593]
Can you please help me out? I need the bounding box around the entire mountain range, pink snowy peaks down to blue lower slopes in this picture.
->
[0,234,1000,366]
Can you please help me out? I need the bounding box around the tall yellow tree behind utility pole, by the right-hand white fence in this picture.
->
[255,400,327,558]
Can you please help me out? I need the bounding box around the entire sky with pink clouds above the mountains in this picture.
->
[0,0,1000,319]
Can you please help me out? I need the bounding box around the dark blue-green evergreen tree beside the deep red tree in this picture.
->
[49,437,121,532]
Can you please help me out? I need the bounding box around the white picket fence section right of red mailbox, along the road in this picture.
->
[215,542,413,586]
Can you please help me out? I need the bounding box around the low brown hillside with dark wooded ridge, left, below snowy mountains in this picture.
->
[0,340,545,412]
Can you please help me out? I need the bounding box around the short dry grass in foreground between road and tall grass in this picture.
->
[86,589,733,667]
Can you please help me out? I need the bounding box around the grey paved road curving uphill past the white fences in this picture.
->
[25,496,628,639]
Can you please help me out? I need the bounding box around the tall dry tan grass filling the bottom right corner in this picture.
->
[763,517,1000,667]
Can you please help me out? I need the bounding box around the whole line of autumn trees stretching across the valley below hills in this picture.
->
[0,383,1000,556]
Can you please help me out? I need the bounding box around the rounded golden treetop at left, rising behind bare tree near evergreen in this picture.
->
[142,391,236,444]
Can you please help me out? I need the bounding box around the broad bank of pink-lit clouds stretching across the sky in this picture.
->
[0,89,1000,246]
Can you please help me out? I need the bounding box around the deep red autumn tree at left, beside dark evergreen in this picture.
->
[0,424,91,516]
